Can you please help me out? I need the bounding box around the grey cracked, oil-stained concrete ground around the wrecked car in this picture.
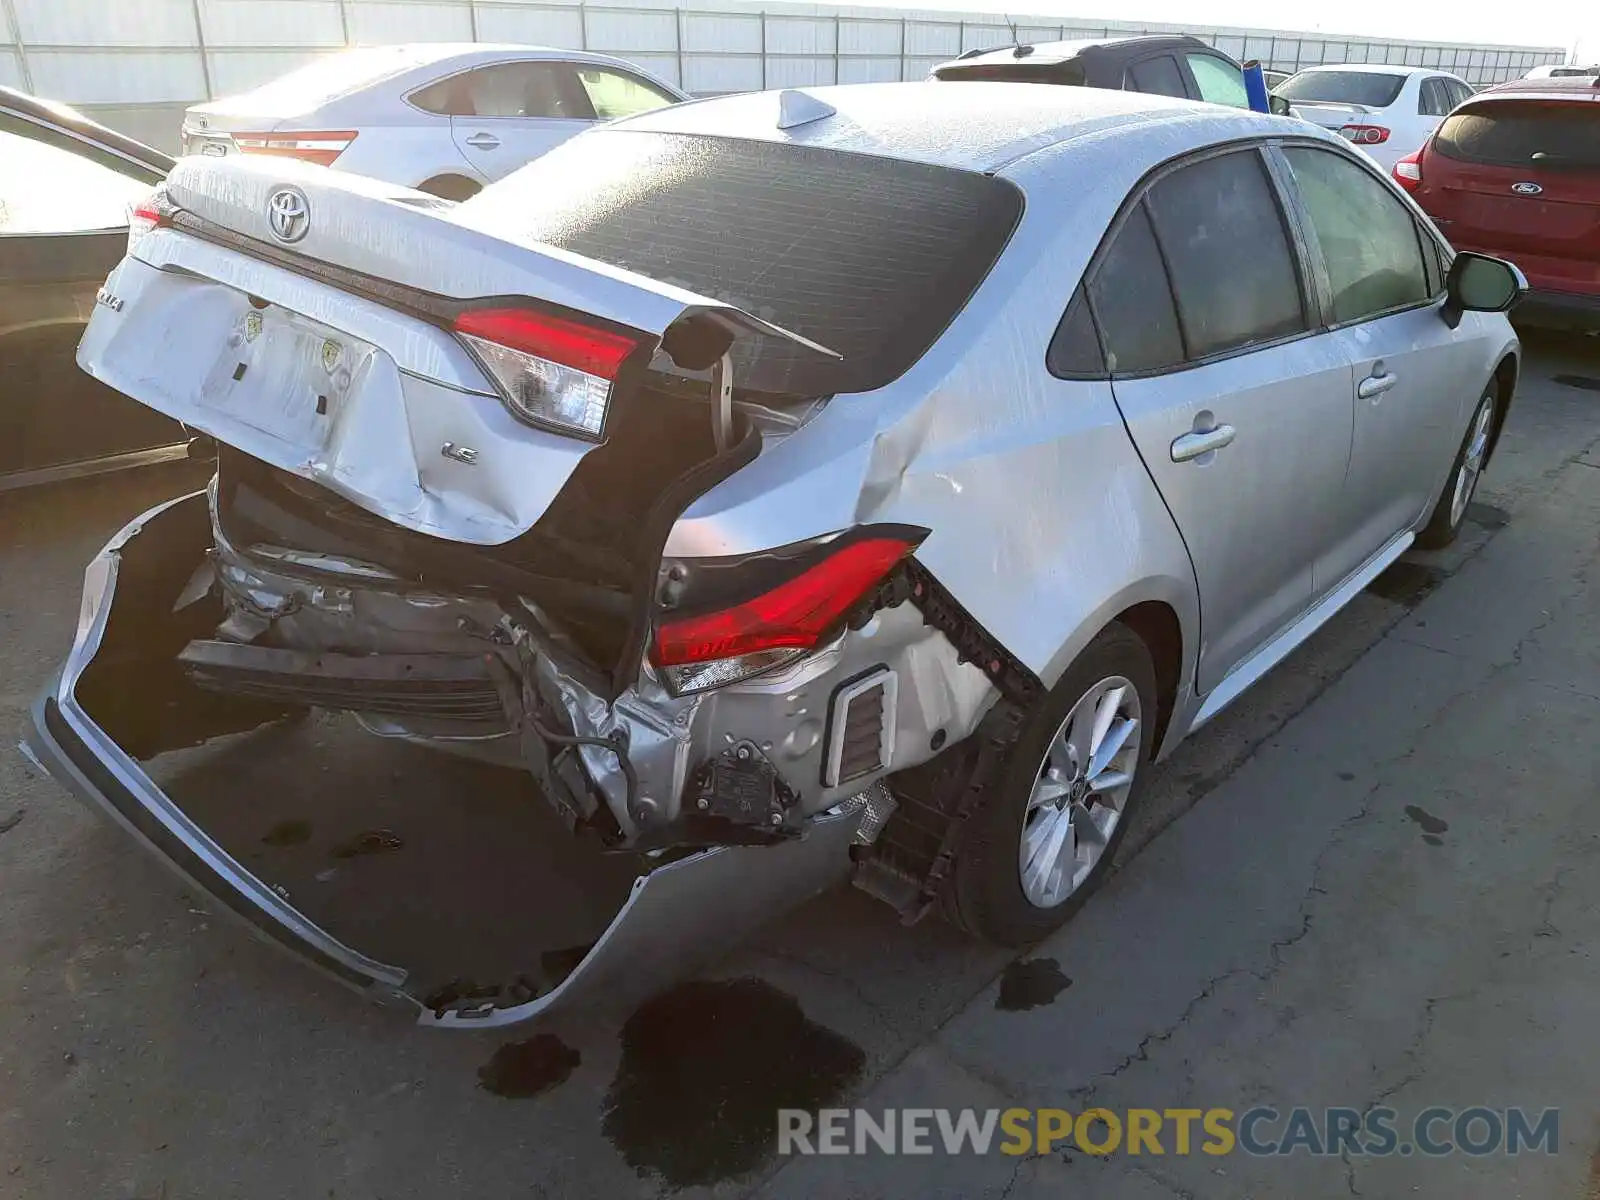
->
[0,341,1600,1200]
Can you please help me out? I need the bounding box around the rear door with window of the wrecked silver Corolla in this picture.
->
[1088,147,1350,693]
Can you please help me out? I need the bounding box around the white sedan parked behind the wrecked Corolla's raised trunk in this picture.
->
[182,43,688,200]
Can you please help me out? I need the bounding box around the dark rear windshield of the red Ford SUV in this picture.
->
[1434,101,1600,170]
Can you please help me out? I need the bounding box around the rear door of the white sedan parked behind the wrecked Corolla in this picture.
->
[450,61,595,182]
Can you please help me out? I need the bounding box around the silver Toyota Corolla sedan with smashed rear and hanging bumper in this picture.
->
[29,83,1523,1027]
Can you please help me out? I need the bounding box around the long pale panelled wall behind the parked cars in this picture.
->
[0,0,1563,147]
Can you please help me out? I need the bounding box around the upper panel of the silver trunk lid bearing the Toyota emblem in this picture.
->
[152,155,840,370]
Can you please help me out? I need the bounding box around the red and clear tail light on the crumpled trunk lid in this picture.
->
[454,309,638,442]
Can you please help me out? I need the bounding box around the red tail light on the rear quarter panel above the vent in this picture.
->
[650,526,928,694]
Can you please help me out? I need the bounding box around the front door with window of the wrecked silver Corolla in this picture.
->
[1282,146,1483,589]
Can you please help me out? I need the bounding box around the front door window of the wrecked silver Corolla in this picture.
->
[1283,146,1432,325]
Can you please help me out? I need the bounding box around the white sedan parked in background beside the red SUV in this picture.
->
[1275,62,1472,171]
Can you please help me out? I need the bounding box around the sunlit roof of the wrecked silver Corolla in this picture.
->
[608,82,1294,171]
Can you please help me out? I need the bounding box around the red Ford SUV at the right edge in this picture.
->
[1394,77,1600,328]
